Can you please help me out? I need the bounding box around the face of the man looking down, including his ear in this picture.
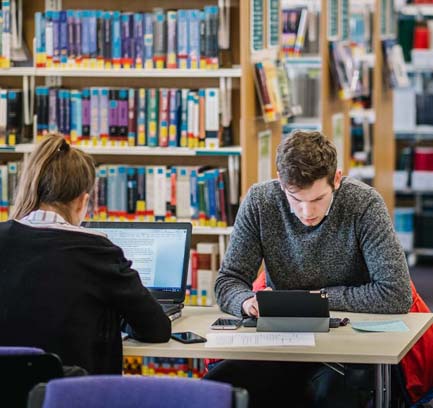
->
[283,171,341,227]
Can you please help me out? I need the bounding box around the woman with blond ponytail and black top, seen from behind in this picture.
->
[0,135,171,374]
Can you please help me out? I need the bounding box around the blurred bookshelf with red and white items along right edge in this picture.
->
[394,4,433,264]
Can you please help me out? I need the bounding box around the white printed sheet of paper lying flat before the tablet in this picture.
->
[205,332,316,347]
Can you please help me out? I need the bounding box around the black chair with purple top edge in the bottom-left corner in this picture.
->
[0,347,63,408]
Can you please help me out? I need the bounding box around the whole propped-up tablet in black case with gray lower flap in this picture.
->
[256,290,329,332]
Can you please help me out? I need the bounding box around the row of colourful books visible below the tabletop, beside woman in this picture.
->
[123,356,205,378]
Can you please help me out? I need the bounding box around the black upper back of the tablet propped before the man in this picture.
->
[256,290,329,317]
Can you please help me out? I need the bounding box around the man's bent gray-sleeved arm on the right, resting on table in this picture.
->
[326,191,412,313]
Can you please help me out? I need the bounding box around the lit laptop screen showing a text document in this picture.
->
[96,228,187,292]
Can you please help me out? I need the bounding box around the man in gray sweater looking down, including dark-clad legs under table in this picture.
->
[207,131,412,407]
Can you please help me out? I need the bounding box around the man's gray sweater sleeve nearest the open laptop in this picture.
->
[215,187,263,316]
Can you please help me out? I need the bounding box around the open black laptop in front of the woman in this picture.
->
[83,222,192,320]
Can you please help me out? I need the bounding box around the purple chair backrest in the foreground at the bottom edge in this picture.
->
[27,375,248,408]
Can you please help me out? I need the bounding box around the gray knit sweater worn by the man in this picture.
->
[215,178,412,316]
